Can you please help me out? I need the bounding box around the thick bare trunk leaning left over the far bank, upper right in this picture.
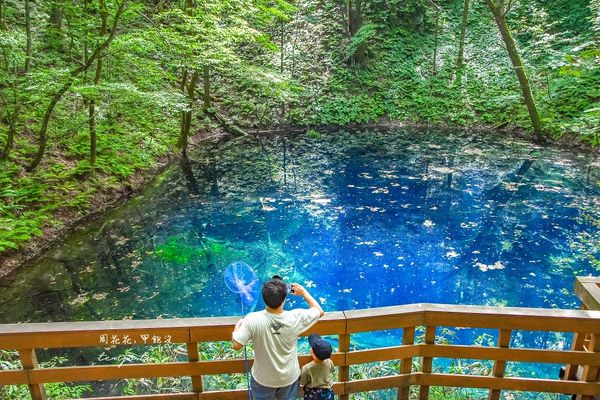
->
[485,0,544,141]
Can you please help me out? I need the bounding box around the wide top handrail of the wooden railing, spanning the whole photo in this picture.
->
[0,304,600,350]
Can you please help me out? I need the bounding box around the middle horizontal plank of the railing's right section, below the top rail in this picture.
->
[417,344,600,365]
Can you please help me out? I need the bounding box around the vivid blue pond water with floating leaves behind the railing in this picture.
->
[0,130,600,390]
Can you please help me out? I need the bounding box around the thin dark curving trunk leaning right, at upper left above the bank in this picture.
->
[27,0,127,172]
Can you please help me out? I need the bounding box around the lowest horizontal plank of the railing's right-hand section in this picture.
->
[413,372,600,395]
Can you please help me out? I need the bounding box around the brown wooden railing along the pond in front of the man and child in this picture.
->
[0,304,600,400]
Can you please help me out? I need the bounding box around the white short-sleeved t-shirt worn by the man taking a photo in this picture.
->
[233,308,320,388]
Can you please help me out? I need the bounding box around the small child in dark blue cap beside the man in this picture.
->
[300,333,335,400]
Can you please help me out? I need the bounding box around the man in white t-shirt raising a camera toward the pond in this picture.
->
[232,275,324,400]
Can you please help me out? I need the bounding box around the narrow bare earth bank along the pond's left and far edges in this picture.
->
[0,121,600,278]
